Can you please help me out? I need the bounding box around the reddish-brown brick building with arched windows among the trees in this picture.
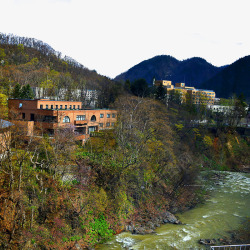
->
[8,99,117,142]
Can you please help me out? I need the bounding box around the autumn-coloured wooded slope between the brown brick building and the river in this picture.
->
[0,92,249,249]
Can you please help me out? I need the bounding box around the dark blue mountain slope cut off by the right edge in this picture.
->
[201,55,250,100]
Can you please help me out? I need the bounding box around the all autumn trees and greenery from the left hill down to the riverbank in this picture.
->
[0,34,249,249]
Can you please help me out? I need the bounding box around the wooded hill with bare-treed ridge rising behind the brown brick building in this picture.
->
[0,33,121,107]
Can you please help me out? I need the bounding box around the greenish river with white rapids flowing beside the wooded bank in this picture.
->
[98,172,250,250]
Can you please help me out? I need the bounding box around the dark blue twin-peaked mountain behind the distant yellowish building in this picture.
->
[115,55,223,87]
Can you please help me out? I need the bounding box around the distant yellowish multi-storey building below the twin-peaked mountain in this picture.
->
[154,80,215,105]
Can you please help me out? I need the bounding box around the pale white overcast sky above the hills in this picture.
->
[0,0,250,78]
